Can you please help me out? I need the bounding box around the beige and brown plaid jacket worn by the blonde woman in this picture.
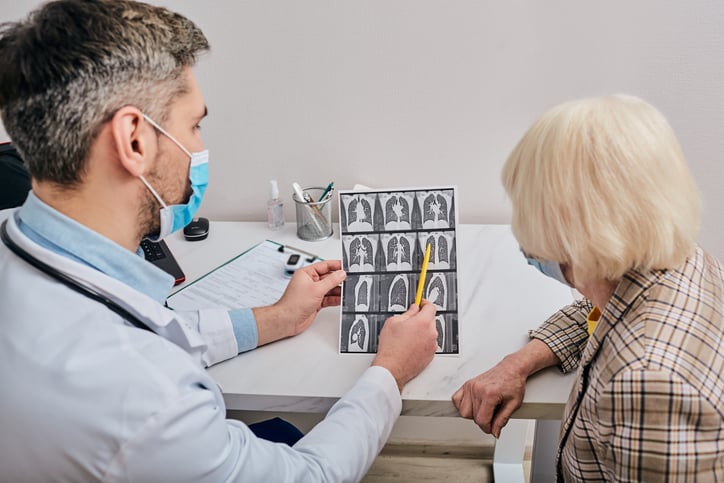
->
[531,248,724,482]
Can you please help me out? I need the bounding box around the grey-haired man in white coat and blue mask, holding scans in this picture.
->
[0,0,437,482]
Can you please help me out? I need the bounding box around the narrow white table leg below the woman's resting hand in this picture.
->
[493,419,529,483]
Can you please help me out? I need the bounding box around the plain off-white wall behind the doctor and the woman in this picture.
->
[0,0,724,260]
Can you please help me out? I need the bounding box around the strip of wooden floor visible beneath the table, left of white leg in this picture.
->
[362,444,493,483]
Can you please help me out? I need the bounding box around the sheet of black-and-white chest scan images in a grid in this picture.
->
[339,186,458,354]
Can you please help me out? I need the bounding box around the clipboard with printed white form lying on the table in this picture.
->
[166,240,321,310]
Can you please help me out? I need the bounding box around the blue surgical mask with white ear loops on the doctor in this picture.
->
[139,114,209,241]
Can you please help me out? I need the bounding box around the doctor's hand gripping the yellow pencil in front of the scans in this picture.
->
[372,300,437,392]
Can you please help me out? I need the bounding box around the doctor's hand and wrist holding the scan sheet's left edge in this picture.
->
[254,260,347,345]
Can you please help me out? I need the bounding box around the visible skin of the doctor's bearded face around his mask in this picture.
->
[146,67,207,233]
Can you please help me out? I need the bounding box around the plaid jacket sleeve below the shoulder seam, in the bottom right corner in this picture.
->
[597,369,724,481]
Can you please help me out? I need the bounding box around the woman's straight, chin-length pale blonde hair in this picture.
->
[502,95,701,282]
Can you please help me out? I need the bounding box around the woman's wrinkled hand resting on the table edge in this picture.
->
[452,339,558,438]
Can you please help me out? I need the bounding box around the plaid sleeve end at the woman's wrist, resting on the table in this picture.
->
[528,299,593,373]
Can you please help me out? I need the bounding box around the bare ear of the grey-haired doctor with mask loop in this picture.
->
[110,106,156,177]
